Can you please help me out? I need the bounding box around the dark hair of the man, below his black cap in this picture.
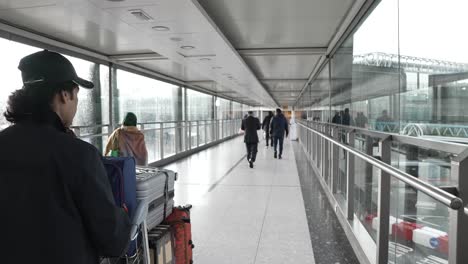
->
[3,81,78,124]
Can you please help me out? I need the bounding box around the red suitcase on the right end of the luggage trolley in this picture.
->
[164,205,195,264]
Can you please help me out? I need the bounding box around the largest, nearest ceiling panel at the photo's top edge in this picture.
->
[200,0,354,49]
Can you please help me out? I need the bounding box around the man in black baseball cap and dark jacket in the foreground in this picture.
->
[0,51,130,264]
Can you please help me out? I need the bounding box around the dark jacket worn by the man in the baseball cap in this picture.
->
[0,112,130,264]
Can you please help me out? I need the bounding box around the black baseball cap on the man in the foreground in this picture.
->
[18,50,94,89]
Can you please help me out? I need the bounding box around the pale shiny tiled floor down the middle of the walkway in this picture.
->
[167,137,315,264]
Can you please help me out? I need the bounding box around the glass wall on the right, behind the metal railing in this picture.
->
[298,0,468,263]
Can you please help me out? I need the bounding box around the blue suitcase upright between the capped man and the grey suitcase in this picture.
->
[103,157,137,257]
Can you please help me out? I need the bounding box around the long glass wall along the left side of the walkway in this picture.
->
[0,35,247,162]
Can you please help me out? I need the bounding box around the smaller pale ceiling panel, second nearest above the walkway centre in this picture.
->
[244,55,320,79]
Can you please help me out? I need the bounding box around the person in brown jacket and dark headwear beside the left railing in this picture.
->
[104,112,148,166]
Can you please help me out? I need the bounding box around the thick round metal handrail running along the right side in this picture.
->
[298,122,462,210]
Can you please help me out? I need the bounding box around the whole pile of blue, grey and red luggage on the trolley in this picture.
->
[103,157,194,264]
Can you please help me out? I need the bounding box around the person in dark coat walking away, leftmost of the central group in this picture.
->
[241,111,261,168]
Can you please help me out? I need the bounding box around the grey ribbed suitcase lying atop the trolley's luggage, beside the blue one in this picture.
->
[136,166,177,229]
